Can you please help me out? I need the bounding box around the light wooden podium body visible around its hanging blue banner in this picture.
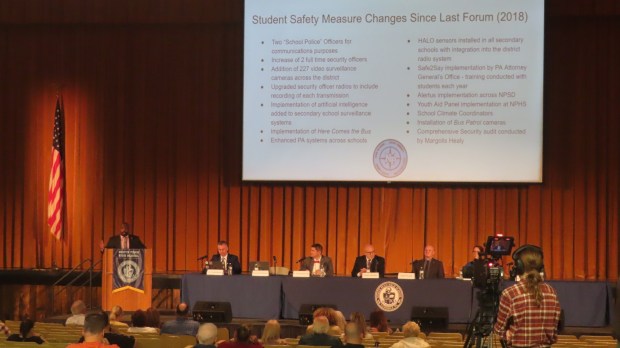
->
[101,249,153,311]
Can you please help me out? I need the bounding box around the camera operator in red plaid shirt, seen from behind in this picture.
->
[494,246,560,347]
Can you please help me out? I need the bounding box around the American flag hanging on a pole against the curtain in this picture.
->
[47,96,65,239]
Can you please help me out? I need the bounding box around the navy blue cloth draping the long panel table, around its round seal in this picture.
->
[182,274,613,327]
